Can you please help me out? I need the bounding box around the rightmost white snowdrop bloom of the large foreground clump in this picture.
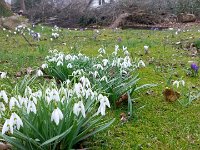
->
[97,94,110,116]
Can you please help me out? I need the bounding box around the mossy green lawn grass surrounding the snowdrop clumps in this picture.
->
[0,26,200,150]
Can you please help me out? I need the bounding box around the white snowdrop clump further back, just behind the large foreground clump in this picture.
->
[41,45,151,108]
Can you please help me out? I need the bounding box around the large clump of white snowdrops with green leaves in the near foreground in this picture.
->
[0,75,114,150]
